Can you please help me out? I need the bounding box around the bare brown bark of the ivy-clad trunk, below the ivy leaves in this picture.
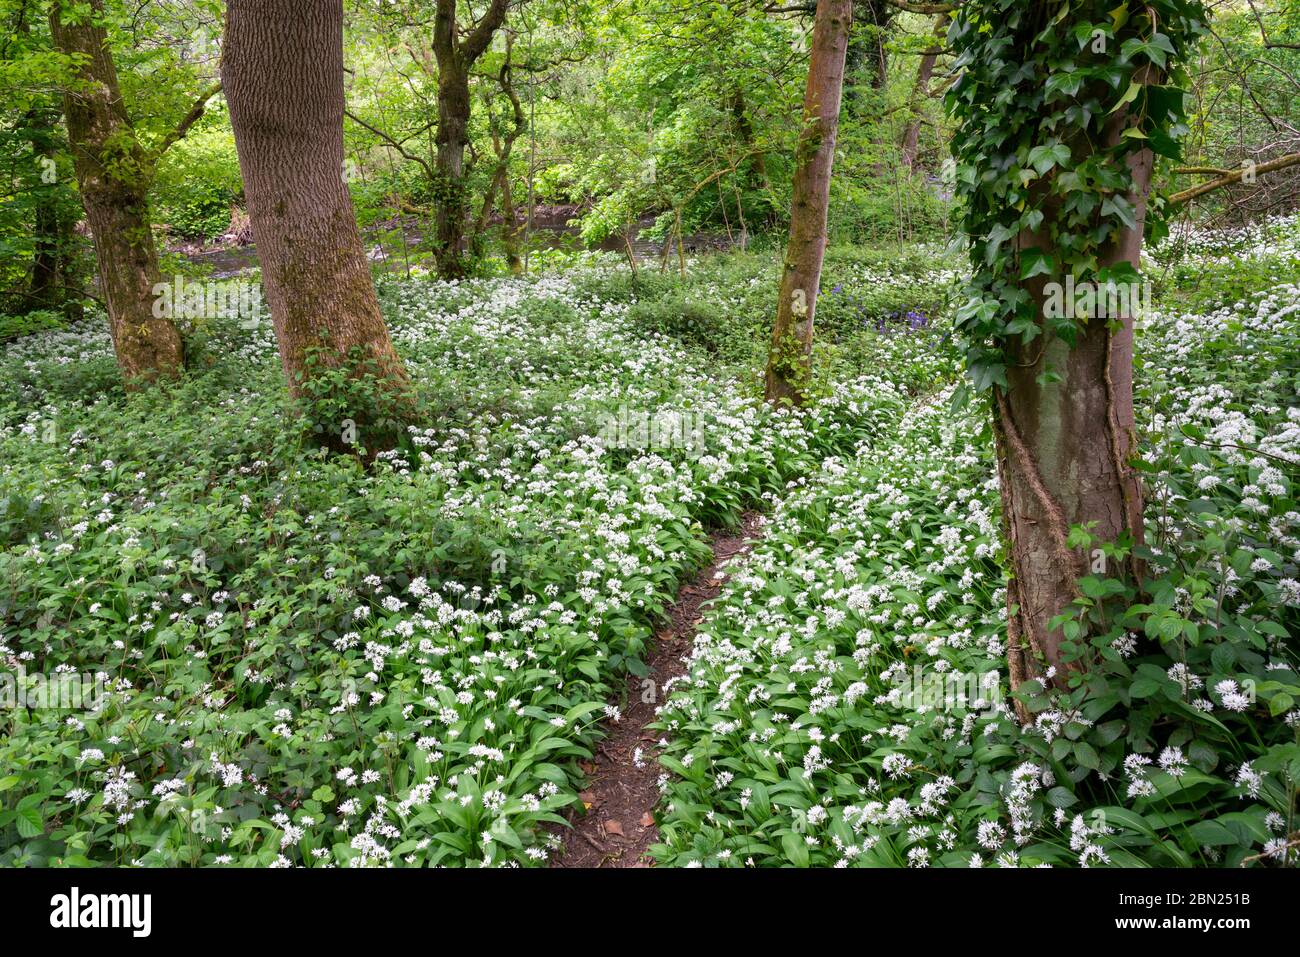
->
[993,127,1153,719]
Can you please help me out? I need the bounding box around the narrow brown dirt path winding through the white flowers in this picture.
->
[551,512,763,867]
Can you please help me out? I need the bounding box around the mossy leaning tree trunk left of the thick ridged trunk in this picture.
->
[49,0,183,389]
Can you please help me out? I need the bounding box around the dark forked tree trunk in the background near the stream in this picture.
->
[433,0,510,280]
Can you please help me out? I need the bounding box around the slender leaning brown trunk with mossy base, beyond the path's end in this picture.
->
[767,0,853,404]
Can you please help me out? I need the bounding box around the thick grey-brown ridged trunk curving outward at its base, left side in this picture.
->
[221,0,410,421]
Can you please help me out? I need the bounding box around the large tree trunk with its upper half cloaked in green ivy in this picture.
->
[949,0,1204,720]
